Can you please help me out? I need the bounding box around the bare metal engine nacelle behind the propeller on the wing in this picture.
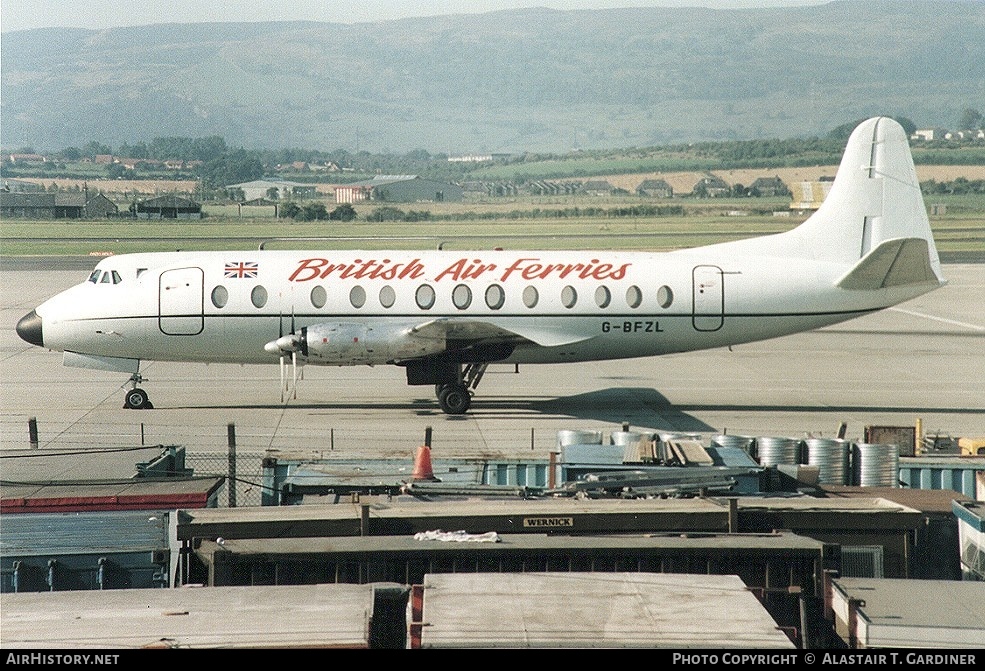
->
[304,322,445,366]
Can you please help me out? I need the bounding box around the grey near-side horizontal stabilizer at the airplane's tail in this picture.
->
[835,238,941,291]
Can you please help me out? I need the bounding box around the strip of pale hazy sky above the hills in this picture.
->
[0,0,827,32]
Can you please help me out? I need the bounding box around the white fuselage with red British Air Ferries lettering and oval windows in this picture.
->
[28,250,926,365]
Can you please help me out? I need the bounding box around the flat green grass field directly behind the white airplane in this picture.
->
[0,200,985,257]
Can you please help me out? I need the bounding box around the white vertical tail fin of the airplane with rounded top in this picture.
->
[791,117,942,283]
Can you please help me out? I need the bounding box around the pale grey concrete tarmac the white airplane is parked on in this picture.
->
[0,258,985,468]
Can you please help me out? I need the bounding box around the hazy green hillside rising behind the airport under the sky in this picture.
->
[0,0,985,153]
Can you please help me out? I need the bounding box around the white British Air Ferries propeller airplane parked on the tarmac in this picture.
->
[17,117,945,414]
